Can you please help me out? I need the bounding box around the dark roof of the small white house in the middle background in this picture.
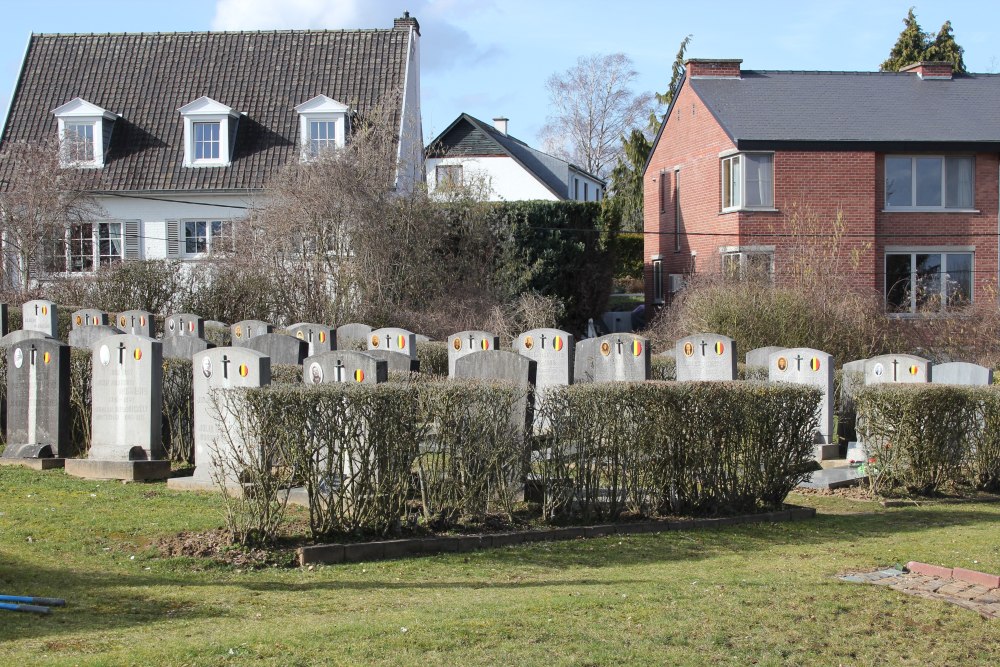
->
[426,113,604,199]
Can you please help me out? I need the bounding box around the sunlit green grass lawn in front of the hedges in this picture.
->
[0,467,1000,666]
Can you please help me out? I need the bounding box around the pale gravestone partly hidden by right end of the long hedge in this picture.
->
[767,347,840,461]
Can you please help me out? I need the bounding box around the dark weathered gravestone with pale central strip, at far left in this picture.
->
[0,340,71,470]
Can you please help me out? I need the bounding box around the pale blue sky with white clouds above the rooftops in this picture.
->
[0,0,1000,145]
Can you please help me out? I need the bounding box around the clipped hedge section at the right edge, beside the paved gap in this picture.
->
[855,384,1000,495]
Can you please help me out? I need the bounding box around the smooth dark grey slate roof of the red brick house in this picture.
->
[688,70,1000,151]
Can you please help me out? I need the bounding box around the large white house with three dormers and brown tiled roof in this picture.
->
[0,13,423,280]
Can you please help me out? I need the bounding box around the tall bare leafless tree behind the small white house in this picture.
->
[542,53,653,178]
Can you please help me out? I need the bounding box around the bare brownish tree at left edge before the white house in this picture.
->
[0,141,101,292]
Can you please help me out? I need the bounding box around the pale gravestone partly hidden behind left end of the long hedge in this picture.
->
[167,347,271,490]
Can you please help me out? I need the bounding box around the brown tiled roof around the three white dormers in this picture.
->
[0,29,409,191]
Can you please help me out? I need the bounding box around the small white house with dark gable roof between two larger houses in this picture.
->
[425,113,605,201]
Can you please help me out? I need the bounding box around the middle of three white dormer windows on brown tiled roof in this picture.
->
[177,97,240,167]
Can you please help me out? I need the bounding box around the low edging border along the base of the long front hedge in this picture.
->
[296,505,816,566]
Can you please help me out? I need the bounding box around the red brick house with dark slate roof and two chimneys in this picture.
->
[643,59,1000,314]
